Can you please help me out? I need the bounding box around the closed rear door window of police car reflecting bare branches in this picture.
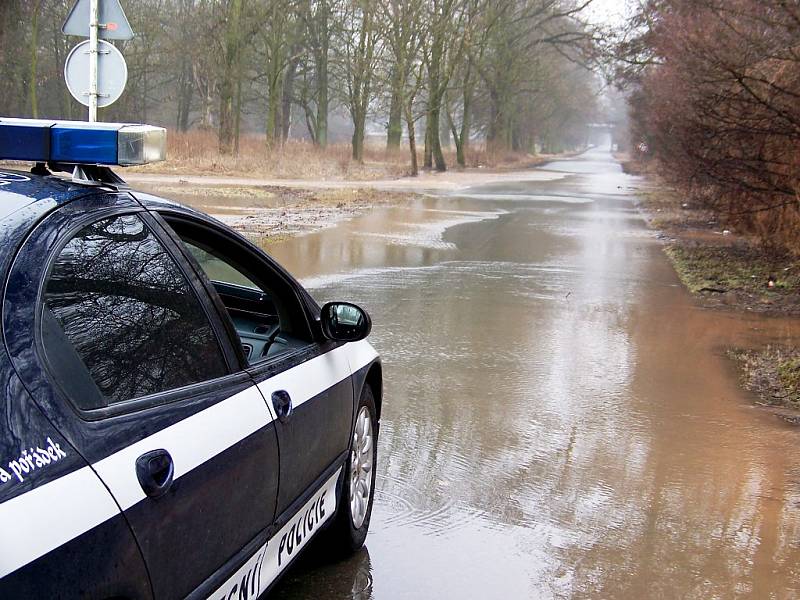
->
[46,215,225,401]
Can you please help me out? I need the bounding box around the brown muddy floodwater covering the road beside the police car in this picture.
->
[236,150,800,600]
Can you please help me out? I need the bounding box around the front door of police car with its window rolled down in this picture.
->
[155,211,354,525]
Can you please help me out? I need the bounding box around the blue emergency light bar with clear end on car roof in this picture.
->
[0,118,167,167]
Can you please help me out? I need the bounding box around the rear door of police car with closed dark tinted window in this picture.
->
[3,194,279,598]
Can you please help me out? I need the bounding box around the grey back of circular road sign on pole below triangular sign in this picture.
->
[64,40,128,108]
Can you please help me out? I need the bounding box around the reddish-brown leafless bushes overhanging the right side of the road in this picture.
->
[620,0,800,251]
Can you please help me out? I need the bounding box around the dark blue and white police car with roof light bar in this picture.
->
[0,119,382,600]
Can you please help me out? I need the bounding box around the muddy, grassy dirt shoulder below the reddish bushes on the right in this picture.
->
[640,177,800,424]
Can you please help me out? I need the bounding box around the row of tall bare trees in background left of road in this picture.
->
[0,0,596,172]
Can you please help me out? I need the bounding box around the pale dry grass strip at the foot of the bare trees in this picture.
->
[126,130,564,181]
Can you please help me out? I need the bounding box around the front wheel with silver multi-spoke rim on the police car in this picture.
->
[330,385,378,555]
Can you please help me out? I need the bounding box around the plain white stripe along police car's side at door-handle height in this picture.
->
[0,340,378,578]
